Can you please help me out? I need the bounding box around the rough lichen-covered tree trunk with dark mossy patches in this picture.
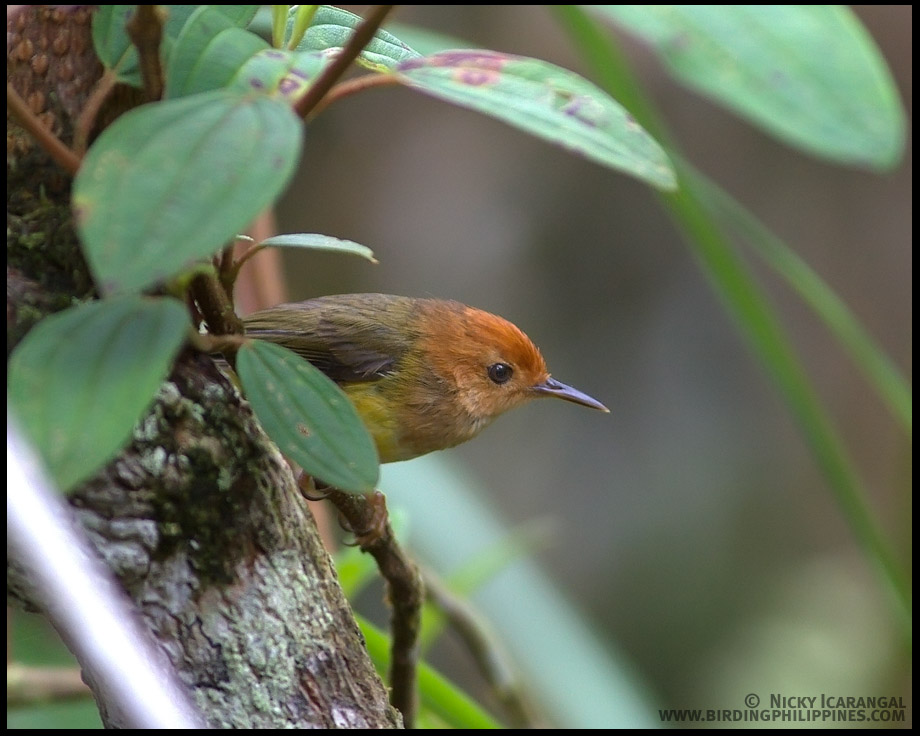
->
[7,6,400,728]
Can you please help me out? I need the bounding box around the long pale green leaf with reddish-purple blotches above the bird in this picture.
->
[395,51,676,189]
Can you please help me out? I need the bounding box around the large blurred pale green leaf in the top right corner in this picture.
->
[584,5,905,168]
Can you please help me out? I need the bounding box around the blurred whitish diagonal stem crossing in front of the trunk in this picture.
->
[6,416,201,729]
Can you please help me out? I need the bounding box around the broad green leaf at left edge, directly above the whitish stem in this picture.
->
[7,295,189,490]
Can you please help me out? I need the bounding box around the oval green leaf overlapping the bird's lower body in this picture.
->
[236,340,380,493]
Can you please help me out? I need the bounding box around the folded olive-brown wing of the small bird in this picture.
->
[243,294,410,383]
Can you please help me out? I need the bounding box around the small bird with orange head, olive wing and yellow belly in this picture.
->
[243,294,609,463]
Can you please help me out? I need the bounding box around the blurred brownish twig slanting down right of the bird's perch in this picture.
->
[423,570,546,728]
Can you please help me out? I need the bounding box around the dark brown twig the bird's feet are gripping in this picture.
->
[327,488,424,728]
